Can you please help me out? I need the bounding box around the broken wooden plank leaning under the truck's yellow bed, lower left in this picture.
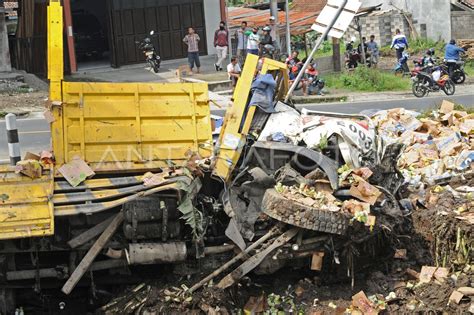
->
[61,211,123,294]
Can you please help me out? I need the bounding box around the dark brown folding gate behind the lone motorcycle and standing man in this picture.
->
[108,0,207,67]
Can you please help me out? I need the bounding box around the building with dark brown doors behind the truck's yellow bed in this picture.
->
[11,0,226,74]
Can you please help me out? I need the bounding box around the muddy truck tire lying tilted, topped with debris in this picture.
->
[262,189,350,235]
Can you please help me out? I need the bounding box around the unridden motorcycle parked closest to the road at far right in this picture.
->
[412,66,456,97]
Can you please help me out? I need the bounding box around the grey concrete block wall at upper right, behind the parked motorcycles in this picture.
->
[362,0,451,41]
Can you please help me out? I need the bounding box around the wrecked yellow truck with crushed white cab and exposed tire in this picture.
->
[0,0,403,312]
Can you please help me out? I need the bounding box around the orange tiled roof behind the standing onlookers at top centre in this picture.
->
[229,7,319,35]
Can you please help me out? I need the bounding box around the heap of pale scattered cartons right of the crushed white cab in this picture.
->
[372,100,474,185]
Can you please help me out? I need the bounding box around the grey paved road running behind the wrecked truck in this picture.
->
[0,92,474,161]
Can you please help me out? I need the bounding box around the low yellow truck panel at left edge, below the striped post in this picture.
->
[0,168,54,239]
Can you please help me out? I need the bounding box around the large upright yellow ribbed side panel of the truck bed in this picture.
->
[52,82,212,171]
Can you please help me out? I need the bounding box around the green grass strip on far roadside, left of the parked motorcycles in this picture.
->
[325,66,411,92]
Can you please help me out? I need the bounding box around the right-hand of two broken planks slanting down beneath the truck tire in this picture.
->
[217,228,300,289]
